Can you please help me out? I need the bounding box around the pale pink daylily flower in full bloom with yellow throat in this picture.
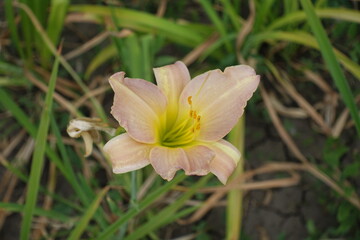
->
[104,62,260,184]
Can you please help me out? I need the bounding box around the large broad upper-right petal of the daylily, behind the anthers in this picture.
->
[180,65,260,141]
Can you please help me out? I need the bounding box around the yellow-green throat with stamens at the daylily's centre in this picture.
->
[161,96,201,147]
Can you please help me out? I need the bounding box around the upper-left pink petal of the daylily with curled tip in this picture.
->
[109,72,167,143]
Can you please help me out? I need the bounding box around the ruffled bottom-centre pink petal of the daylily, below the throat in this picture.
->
[150,145,215,181]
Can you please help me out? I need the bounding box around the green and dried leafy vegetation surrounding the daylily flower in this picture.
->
[0,0,360,240]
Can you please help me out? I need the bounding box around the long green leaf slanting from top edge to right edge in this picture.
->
[301,0,360,136]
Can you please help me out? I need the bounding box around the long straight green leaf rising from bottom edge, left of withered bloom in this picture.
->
[20,48,59,240]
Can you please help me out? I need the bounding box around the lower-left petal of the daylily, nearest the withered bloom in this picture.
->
[104,133,152,173]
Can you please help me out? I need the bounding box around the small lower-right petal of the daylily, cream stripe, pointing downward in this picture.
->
[208,139,241,184]
